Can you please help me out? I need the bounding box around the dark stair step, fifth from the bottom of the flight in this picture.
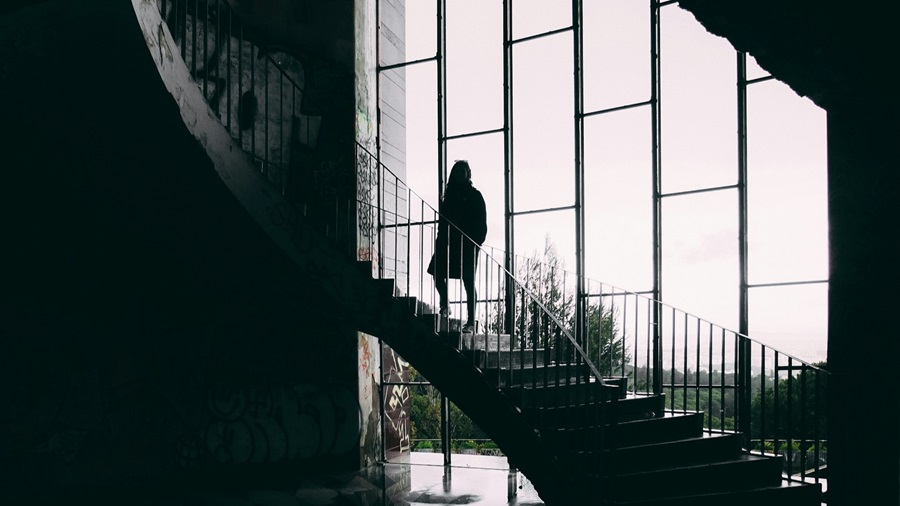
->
[523,395,665,428]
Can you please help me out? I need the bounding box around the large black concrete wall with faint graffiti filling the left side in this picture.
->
[0,0,378,498]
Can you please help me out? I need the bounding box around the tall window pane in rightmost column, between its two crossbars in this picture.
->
[747,80,828,283]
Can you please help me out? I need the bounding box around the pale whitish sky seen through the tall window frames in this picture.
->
[384,0,828,361]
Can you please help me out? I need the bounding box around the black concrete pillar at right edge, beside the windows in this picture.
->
[828,106,900,506]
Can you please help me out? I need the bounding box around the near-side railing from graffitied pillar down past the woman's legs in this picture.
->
[356,145,615,473]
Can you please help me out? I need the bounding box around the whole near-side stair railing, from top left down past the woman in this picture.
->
[158,0,607,482]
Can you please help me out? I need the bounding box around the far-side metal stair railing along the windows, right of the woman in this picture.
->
[492,255,828,483]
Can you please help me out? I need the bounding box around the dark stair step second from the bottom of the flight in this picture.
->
[607,454,782,500]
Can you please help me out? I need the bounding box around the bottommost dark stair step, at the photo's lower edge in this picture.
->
[616,481,822,506]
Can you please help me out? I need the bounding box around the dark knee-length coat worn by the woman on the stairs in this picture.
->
[428,185,487,279]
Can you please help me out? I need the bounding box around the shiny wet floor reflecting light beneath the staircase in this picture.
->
[159,453,544,506]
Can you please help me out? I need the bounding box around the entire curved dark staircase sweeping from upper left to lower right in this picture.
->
[134,1,821,506]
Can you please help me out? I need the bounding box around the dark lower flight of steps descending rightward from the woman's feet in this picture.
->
[408,315,821,506]
